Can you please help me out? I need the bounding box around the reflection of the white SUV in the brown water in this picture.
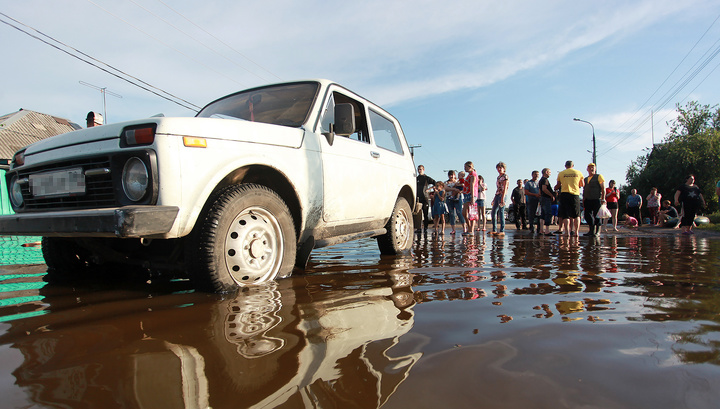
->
[5,270,421,408]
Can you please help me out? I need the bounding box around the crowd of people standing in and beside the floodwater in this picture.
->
[417,161,708,236]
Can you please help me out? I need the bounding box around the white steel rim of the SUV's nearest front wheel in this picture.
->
[224,208,285,285]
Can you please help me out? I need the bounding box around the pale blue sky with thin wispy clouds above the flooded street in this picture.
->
[0,0,720,189]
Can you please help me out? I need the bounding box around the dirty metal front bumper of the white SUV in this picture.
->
[0,206,180,238]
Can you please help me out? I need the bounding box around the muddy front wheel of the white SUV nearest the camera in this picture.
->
[187,184,297,292]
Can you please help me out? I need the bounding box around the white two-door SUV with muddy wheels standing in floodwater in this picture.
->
[0,80,415,292]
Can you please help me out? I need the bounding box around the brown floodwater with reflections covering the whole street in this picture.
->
[0,231,720,409]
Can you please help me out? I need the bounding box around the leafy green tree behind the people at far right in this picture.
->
[625,101,720,210]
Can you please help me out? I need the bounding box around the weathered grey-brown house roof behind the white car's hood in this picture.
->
[0,109,80,159]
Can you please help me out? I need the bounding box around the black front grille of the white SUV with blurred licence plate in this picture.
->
[18,156,117,211]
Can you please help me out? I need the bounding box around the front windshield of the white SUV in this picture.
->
[197,82,320,127]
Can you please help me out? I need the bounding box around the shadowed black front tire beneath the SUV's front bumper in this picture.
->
[42,237,90,282]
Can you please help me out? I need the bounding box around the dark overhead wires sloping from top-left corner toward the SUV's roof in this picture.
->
[0,12,200,112]
